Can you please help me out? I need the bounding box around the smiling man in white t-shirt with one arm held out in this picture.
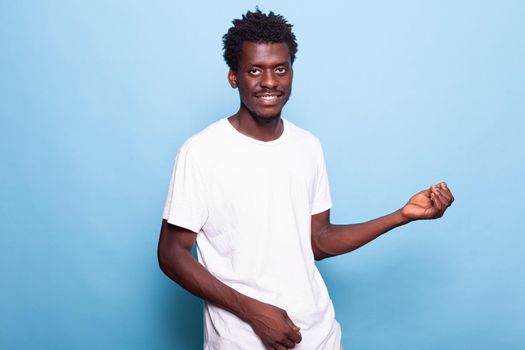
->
[158,10,453,350]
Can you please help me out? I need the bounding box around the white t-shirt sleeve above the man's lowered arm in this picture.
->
[162,148,208,233]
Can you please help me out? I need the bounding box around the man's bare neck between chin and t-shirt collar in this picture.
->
[228,110,284,142]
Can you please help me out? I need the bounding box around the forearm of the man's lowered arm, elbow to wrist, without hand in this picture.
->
[159,248,255,320]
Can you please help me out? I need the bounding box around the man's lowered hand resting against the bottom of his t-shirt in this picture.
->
[244,300,301,350]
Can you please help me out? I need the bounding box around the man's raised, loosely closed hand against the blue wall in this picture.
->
[401,182,454,220]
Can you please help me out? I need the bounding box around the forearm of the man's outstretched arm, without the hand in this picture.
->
[313,209,411,260]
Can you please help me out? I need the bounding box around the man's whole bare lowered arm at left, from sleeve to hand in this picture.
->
[157,220,301,349]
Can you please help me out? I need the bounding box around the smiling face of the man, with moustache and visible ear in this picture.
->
[228,41,293,120]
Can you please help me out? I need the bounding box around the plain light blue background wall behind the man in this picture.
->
[0,1,525,350]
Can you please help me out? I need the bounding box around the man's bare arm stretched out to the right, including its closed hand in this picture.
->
[312,182,454,260]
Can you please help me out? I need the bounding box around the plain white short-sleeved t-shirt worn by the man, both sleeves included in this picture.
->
[163,118,341,350]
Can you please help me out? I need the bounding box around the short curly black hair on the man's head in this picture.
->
[222,8,297,72]
